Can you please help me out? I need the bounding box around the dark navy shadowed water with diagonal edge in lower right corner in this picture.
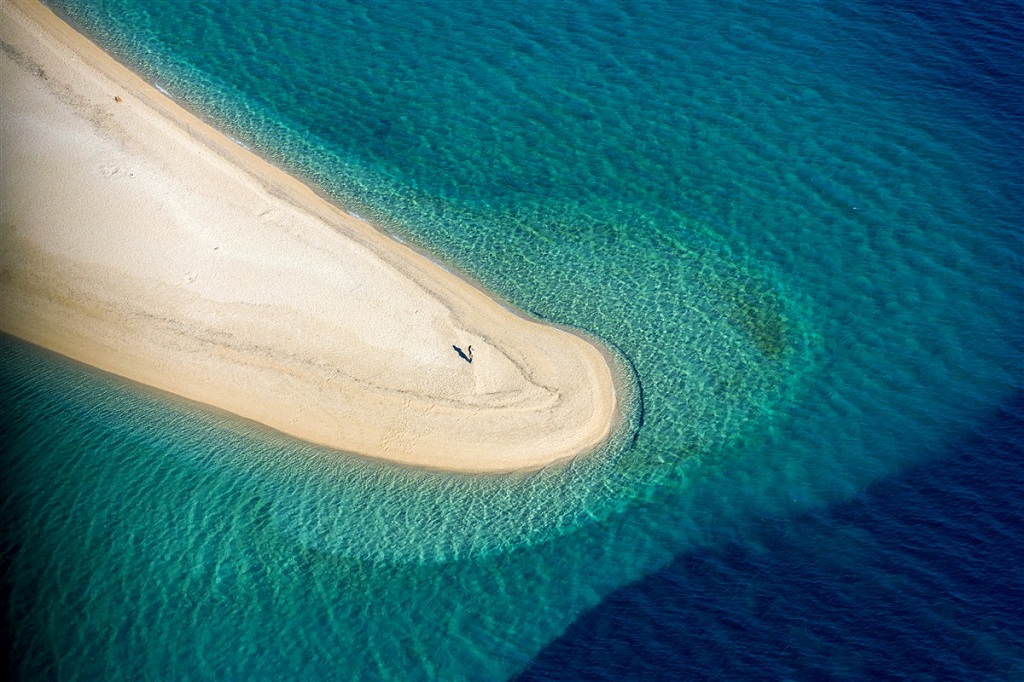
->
[516,395,1024,682]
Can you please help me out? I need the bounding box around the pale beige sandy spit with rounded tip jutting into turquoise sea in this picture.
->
[0,0,616,472]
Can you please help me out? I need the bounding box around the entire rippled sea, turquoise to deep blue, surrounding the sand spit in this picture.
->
[0,0,1024,680]
